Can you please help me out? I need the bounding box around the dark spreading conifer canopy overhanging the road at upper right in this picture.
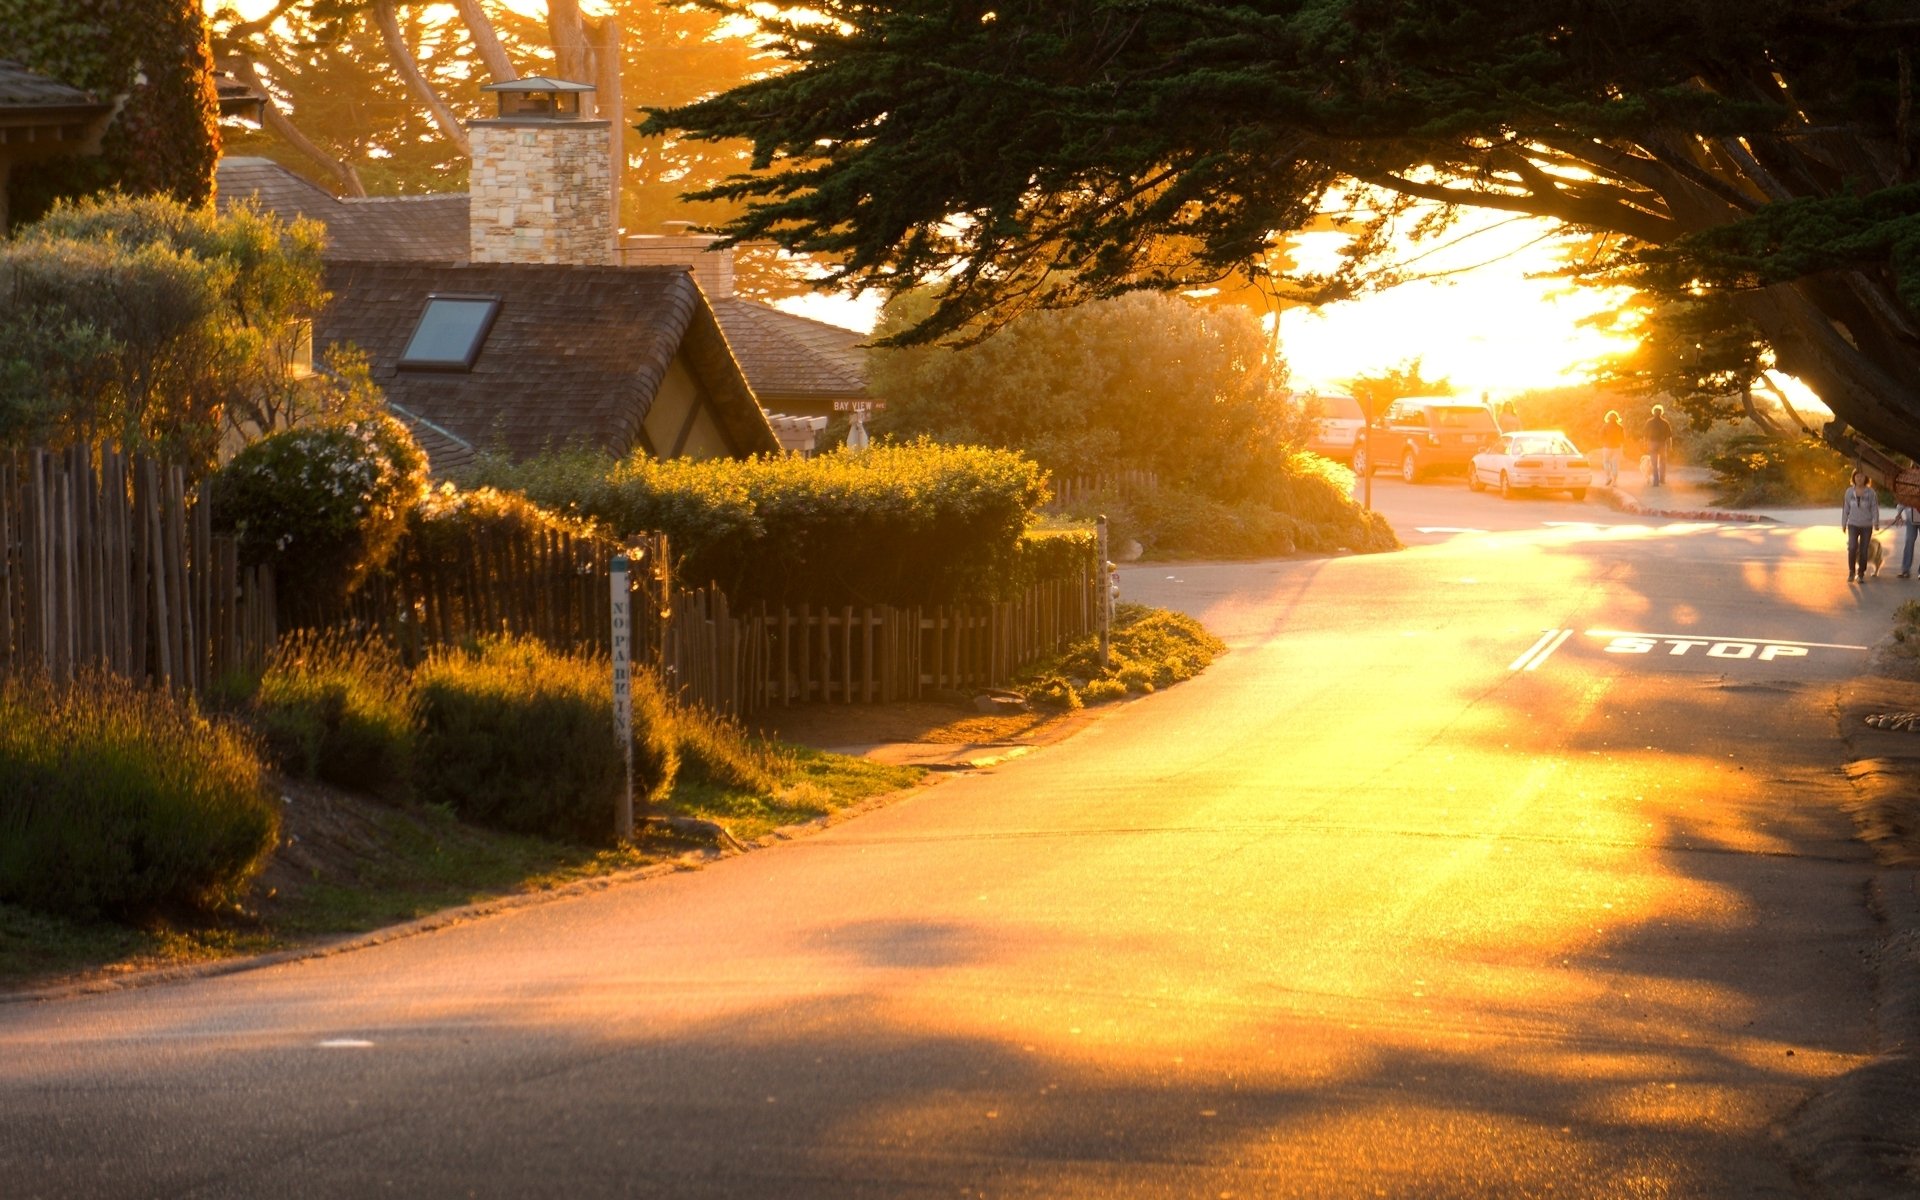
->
[643,0,1920,451]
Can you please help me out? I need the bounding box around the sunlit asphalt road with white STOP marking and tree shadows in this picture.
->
[0,493,1907,1198]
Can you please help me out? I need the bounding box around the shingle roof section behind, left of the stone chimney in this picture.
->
[215,157,468,263]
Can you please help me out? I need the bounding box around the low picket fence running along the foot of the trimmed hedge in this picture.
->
[660,559,1098,716]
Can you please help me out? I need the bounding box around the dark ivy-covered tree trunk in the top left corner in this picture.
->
[0,0,221,221]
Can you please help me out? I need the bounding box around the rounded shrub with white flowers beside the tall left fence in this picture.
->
[213,413,426,618]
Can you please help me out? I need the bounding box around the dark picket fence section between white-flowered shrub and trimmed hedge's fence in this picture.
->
[313,526,668,662]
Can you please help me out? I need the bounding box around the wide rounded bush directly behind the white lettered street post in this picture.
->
[413,639,678,845]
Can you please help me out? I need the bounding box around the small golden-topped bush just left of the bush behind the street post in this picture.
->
[248,634,415,799]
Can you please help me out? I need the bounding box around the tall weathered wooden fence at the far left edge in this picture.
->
[0,447,276,691]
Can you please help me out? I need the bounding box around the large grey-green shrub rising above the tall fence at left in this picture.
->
[0,196,330,462]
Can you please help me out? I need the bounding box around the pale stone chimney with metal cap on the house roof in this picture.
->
[468,75,614,267]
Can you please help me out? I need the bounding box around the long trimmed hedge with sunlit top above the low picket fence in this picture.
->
[470,444,1043,605]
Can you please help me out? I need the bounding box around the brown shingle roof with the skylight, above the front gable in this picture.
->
[315,261,780,467]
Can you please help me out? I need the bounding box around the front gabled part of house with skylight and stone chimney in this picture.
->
[217,79,781,472]
